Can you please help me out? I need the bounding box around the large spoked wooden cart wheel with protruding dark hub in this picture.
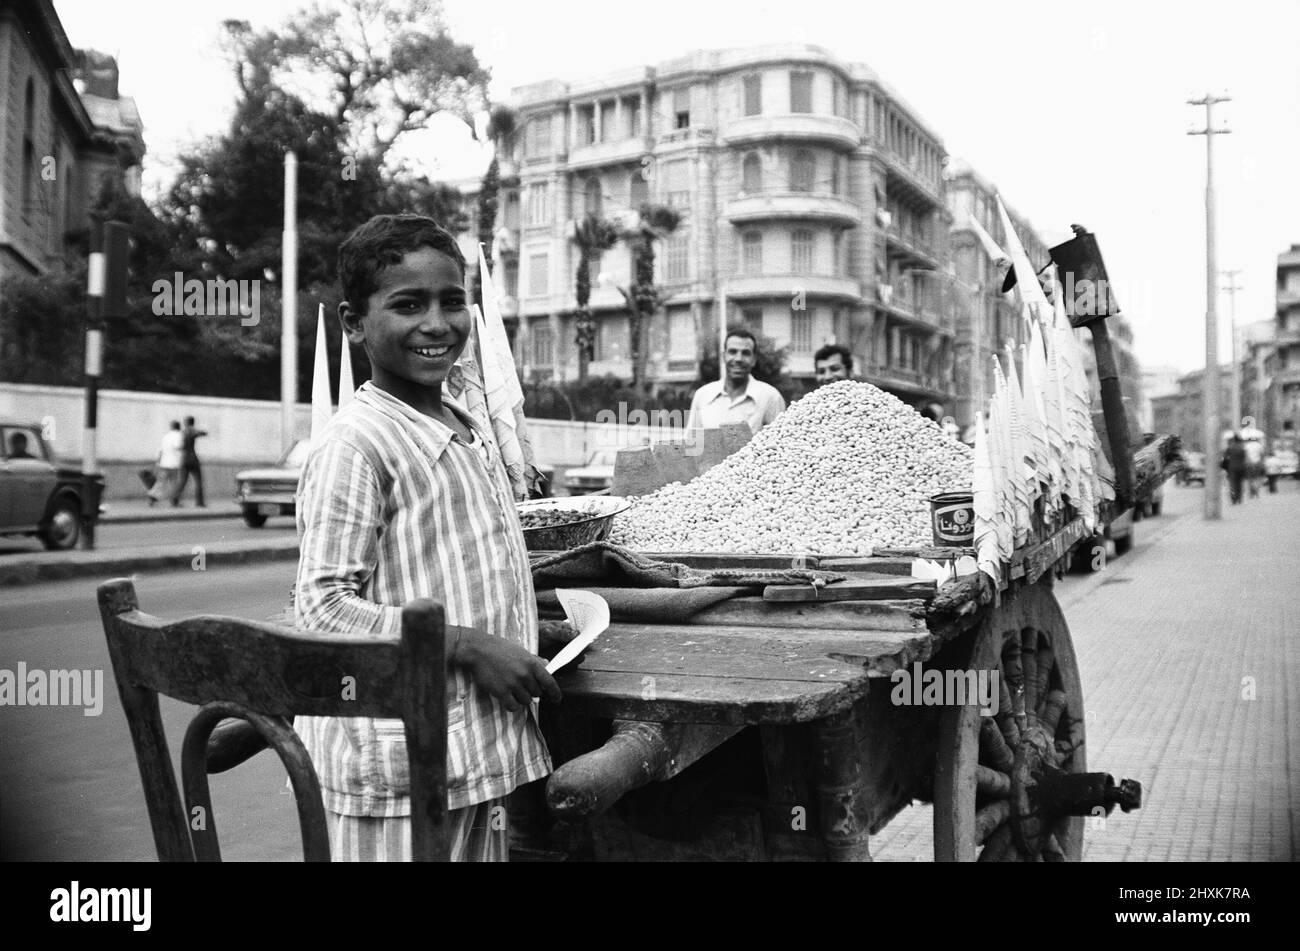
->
[935,582,1086,861]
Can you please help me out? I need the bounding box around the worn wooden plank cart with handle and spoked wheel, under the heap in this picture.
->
[512,521,1140,861]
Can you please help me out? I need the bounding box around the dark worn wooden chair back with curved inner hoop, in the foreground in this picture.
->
[99,578,450,861]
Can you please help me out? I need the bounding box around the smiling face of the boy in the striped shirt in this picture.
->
[338,247,471,403]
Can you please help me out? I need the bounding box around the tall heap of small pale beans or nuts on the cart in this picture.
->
[610,381,974,556]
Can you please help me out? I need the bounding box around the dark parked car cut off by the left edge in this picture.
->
[0,420,104,550]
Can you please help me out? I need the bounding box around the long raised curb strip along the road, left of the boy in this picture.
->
[0,538,298,587]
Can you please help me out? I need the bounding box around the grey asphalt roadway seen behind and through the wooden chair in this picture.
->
[0,511,1158,861]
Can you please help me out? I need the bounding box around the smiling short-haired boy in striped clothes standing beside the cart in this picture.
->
[294,216,560,861]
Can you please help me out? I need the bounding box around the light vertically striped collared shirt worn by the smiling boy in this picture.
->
[294,382,551,817]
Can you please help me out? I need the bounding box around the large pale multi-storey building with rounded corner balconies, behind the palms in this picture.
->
[497,45,956,405]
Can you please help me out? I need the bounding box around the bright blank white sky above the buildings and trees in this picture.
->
[55,0,1300,372]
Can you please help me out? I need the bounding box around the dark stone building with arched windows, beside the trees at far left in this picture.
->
[0,0,144,291]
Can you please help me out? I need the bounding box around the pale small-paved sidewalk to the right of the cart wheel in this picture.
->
[871,482,1300,861]
